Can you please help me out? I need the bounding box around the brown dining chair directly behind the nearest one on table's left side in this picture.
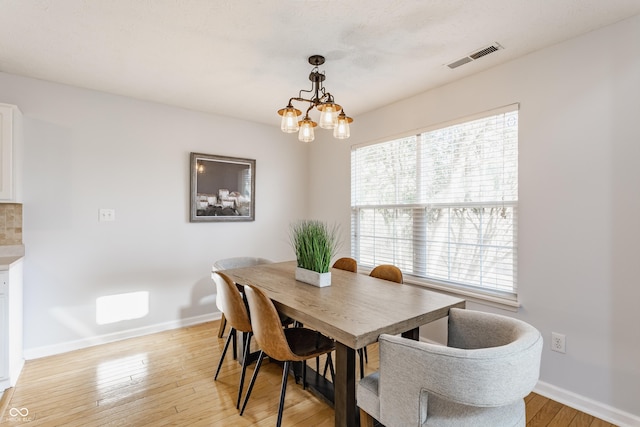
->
[211,271,253,409]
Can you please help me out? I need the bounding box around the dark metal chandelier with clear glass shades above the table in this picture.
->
[278,55,353,142]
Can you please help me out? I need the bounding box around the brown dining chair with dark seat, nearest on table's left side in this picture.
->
[240,285,335,427]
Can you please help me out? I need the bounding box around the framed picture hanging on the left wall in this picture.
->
[190,153,256,222]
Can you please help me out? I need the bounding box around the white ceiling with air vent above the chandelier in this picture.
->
[0,0,640,125]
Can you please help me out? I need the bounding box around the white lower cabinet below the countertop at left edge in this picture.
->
[0,260,24,392]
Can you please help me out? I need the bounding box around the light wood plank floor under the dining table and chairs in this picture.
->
[0,322,612,427]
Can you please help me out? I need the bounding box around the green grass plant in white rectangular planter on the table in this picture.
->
[290,220,339,287]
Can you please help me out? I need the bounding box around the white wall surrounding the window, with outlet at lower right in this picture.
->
[310,17,640,425]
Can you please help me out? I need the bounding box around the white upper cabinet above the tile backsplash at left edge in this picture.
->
[0,104,22,202]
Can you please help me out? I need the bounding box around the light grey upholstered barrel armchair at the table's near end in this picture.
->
[357,308,542,427]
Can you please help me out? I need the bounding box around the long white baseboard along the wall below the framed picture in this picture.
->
[24,312,222,360]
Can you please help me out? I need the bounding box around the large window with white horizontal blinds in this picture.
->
[351,106,518,297]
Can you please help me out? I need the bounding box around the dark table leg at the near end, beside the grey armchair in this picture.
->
[334,342,358,427]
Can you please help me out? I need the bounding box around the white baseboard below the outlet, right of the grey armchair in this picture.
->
[533,381,640,427]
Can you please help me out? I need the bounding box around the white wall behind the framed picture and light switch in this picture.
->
[0,73,307,357]
